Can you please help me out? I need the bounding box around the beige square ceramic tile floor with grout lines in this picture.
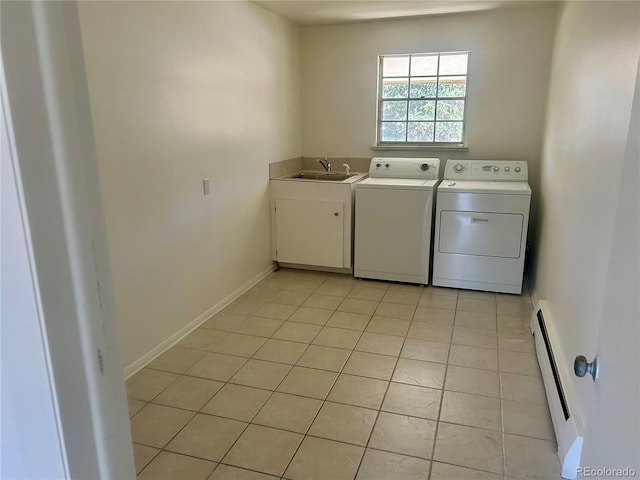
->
[127,270,560,480]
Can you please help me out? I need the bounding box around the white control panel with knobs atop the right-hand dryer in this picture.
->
[444,159,529,182]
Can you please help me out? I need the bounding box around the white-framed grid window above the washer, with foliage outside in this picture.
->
[377,52,469,146]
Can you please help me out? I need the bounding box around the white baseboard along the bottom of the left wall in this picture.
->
[124,265,275,380]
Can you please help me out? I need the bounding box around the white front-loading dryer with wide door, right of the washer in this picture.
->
[433,160,531,294]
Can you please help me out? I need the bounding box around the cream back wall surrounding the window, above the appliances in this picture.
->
[302,7,556,185]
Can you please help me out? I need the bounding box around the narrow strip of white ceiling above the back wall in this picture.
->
[253,0,555,25]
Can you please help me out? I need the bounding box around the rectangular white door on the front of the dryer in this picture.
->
[438,210,524,258]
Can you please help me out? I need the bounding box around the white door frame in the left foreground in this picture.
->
[0,2,135,479]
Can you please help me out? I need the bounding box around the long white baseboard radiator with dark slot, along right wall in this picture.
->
[531,301,584,480]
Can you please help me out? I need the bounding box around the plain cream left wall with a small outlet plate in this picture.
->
[80,2,301,367]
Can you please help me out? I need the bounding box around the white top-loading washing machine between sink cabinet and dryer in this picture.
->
[354,158,440,285]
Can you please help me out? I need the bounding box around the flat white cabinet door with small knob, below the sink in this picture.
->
[275,199,344,268]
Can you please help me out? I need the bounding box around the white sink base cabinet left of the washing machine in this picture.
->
[270,179,353,269]
